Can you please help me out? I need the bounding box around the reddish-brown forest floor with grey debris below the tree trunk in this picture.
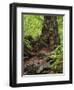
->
[24,48,63,75]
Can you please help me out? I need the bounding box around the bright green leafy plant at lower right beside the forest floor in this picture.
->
[48,45,63,72]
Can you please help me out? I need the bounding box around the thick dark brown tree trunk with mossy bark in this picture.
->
[41,16,59,51]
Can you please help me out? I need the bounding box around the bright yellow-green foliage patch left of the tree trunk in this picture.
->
[23,15,44,39]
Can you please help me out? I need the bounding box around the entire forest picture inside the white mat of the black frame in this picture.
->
[22,14,63,75]
